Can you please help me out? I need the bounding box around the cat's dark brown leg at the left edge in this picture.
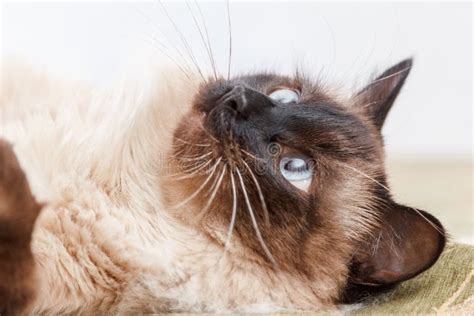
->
[0,139,41,316]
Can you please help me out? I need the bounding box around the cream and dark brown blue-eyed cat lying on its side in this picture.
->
[0,59,446,315]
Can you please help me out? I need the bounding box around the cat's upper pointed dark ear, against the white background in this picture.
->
[353,59,413,130]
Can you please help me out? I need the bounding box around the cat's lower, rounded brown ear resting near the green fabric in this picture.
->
[351,202,446,285]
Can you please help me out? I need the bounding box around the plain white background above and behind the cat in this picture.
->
[2,1,472,160]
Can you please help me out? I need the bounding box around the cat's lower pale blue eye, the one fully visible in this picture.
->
[280,154,314,191]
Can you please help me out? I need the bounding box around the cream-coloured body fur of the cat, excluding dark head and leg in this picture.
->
[0,63,334,314]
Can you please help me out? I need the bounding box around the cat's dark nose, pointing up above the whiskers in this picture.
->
[220,85,274,118]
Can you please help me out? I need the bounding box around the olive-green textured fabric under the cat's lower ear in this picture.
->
[351,244,474,315]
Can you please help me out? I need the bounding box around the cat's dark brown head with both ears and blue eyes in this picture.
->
[165,60,445,302]
